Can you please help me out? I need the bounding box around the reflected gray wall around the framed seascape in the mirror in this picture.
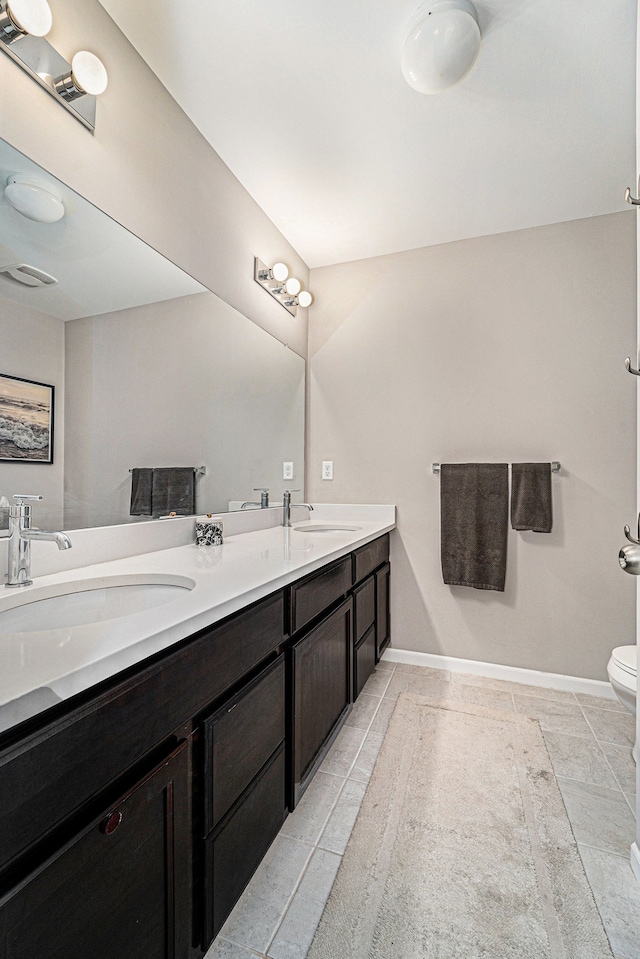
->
[0,299,65,524]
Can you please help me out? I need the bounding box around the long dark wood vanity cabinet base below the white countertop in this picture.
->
[0,536,389,959]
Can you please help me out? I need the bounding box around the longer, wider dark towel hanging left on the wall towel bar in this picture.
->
[440,463,509,592]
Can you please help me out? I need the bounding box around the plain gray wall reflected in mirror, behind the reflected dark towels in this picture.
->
[64,293,305,529]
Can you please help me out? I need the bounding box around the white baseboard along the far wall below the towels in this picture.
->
[382,647,616,699]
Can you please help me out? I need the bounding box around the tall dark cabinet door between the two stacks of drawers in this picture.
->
[291,598,353,808]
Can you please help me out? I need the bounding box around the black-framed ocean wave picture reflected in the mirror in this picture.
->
[0,373,55,464]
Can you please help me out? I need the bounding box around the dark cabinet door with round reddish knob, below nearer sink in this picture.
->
[0,743,191,959]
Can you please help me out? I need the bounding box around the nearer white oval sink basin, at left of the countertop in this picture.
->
[0,573,195,634]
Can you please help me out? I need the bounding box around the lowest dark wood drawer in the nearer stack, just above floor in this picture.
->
[204,746,287,949]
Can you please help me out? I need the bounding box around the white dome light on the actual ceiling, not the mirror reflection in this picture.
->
[400,0,482,94]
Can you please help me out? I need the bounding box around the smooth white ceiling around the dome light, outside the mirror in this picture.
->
[101,0,636,267]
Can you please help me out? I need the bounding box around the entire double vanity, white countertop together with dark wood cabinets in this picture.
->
[0,506,395,959]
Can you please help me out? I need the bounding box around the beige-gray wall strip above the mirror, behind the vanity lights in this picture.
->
[0,0,308,356]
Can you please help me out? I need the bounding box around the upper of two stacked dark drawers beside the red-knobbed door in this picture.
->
[204,654,285,835]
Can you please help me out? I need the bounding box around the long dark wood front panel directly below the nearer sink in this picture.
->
[0,593,284,868]
